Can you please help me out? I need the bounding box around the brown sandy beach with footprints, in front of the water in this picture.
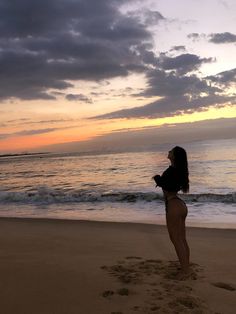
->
[0,218,236,314]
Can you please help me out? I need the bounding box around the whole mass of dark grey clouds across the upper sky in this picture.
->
[0,0,235,119]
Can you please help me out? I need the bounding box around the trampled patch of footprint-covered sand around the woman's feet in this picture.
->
[101,256,208,314]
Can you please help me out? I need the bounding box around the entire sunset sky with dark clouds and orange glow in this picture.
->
[0,0,236,153]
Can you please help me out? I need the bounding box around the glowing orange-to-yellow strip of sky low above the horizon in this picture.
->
[0,106,236,152]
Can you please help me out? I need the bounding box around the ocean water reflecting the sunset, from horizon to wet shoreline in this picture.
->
[0,139,236,228]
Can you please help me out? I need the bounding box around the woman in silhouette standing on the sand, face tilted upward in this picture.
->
[153,146,190,277]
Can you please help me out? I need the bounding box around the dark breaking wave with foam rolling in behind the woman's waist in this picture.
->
[0,186,236,204]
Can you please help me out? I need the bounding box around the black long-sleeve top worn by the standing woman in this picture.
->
[153,166,181,192]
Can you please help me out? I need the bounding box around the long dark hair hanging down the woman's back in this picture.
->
[173,146,189,193]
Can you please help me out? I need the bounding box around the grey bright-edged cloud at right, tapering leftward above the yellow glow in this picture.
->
[88,22,236,119]
